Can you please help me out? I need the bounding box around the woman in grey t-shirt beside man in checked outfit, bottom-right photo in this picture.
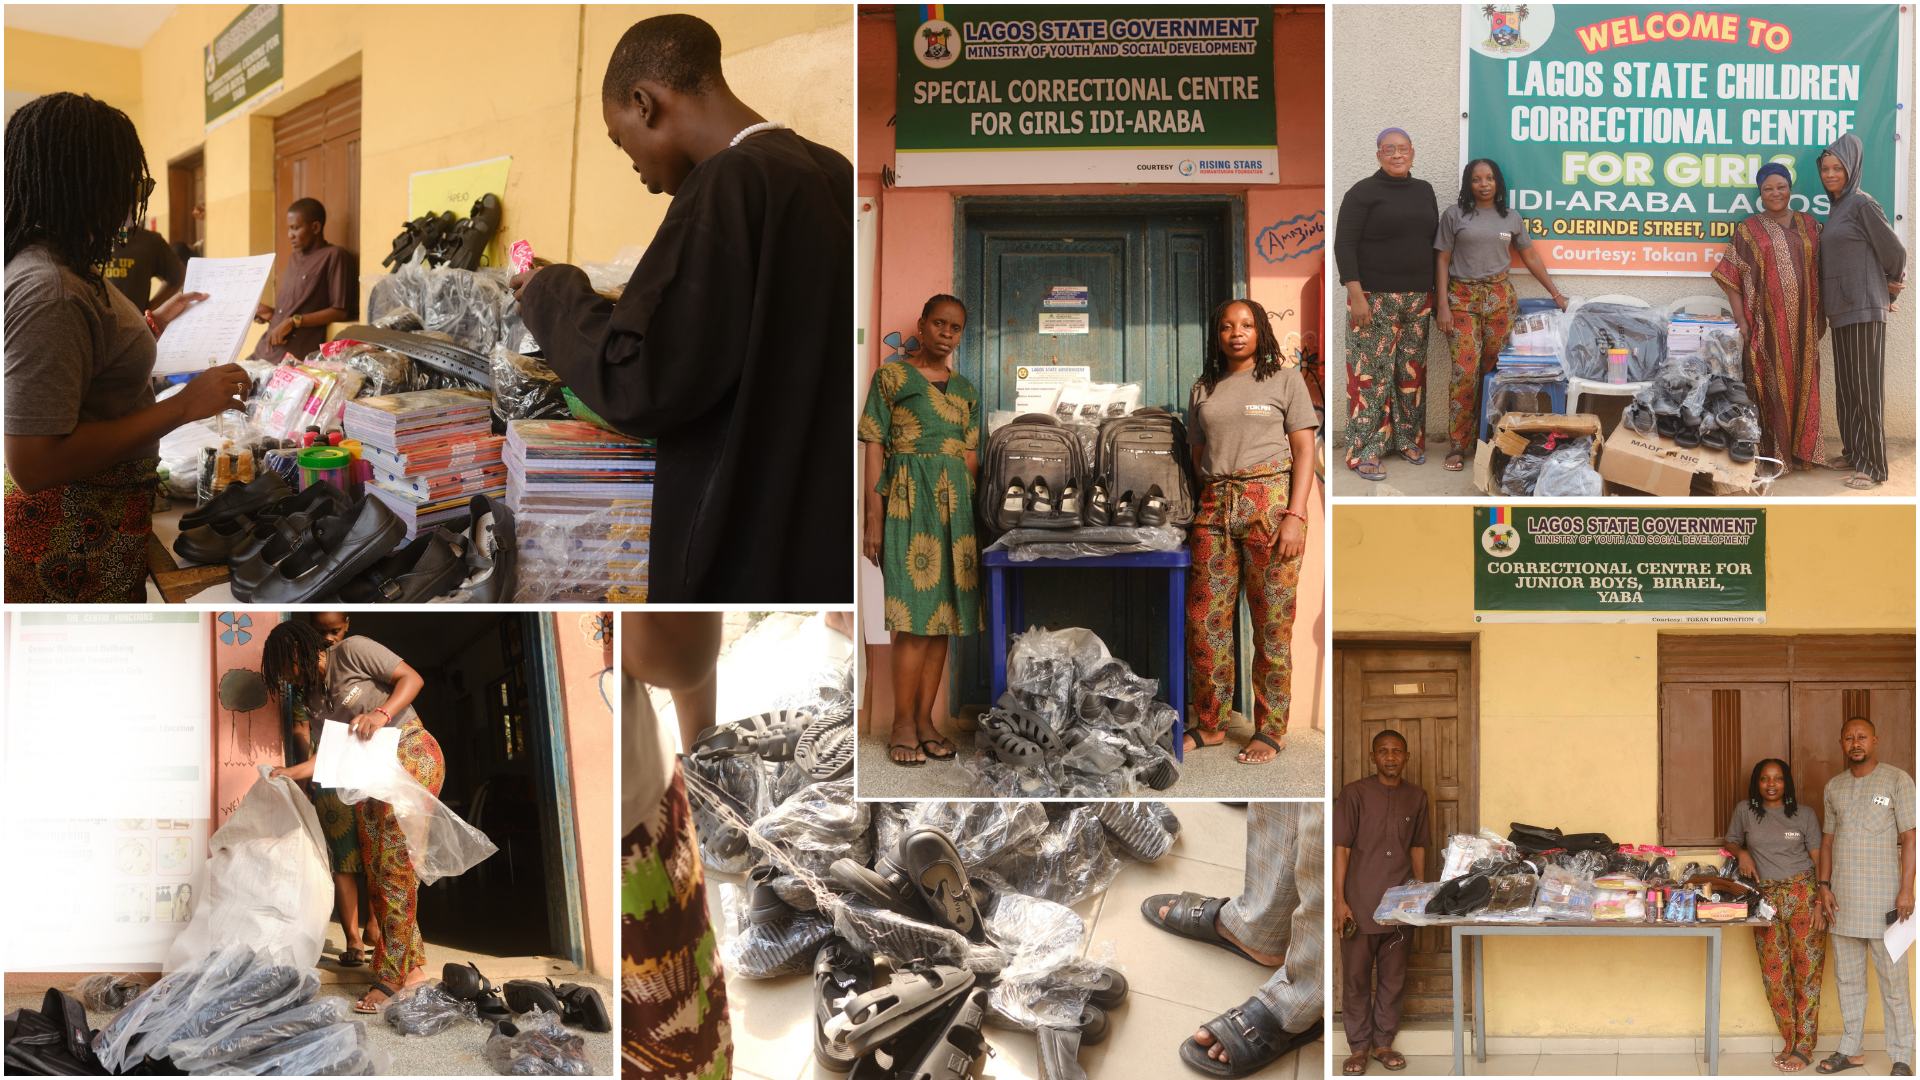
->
[1726,757,1826,1072]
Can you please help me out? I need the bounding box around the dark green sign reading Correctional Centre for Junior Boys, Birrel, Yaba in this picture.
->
[1473,505,1766,625]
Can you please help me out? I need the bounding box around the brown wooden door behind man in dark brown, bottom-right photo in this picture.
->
[1331,644,1480,1020]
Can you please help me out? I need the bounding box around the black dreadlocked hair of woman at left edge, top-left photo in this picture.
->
[6,94,154,292]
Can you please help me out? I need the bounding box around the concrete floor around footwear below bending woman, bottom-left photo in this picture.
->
[6,922,620,1076]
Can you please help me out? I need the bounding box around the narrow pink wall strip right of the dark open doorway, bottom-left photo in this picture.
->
[549,611,620,976]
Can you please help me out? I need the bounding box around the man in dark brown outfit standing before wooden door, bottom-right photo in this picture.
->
[1332,728,1427,1076]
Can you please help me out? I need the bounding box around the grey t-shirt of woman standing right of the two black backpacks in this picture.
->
[1187,367,1319,479]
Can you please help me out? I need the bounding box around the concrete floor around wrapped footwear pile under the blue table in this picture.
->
[854,713,1327,801]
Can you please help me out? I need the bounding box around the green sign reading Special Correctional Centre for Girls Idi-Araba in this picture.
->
[893,4,1279,186]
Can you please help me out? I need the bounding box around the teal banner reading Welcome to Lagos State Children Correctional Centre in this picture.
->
[1466,4,1912,275]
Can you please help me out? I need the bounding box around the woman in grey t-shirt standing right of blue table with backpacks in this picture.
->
[1187,300,1319,765]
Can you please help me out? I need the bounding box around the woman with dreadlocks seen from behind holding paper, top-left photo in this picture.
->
[0,94,252,603]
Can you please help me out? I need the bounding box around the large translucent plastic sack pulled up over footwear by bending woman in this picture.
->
[163,765,334,970]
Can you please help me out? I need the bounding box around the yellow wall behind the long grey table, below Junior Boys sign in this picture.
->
[1332,503,1914,1038]
